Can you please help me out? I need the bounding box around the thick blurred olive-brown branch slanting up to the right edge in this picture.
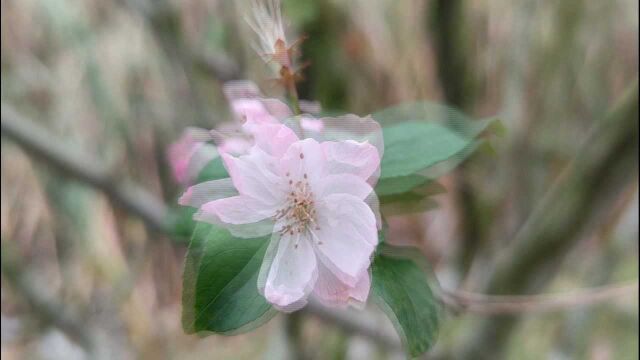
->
[461,81,638,358]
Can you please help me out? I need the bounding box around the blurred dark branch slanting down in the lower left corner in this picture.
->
[1,240,95,353]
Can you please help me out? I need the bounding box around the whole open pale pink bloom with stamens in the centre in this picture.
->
[180,118,381,311]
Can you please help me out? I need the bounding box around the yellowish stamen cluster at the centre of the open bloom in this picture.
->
[274,173,322,248]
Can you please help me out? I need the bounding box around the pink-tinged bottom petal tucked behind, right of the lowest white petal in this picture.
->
[313,262,371,307]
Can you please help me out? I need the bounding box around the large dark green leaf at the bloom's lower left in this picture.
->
[182,223,276,335]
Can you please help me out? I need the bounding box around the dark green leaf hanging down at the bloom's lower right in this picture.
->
[371,254,441,357]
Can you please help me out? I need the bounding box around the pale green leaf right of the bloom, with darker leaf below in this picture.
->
[372,102,499,216]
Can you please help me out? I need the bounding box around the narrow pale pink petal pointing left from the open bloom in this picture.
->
[193,195,275,225]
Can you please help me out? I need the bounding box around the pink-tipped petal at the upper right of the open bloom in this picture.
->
[322,140,380,183]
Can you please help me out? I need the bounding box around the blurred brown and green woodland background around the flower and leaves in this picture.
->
[1,0,638,360]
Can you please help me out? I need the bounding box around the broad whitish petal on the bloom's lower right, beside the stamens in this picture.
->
[313,194,378,287]
